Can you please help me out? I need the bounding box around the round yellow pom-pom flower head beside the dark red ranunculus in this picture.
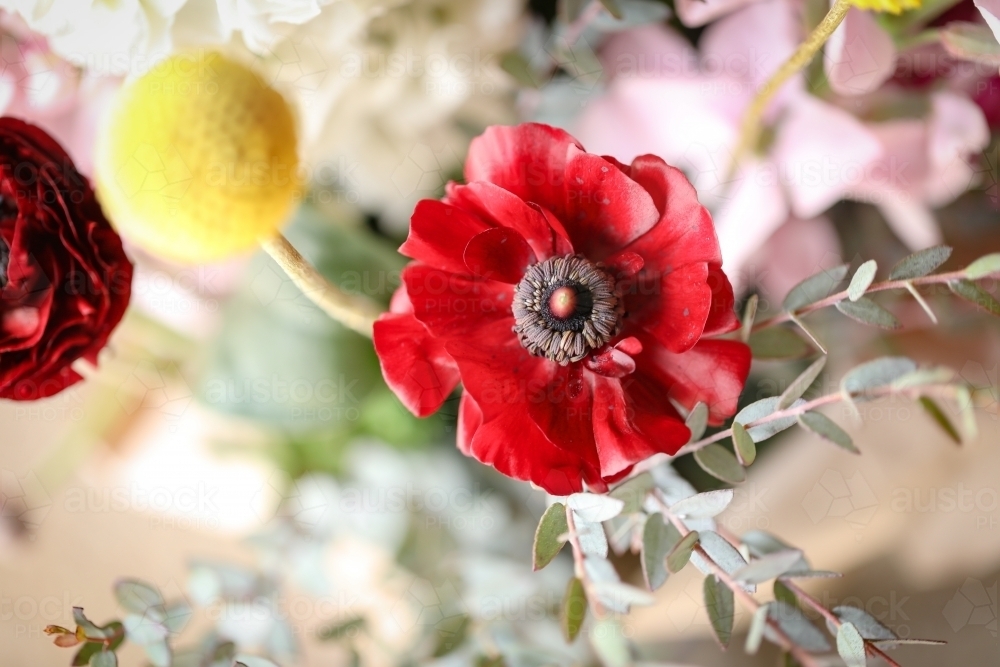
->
[95,52,300,264]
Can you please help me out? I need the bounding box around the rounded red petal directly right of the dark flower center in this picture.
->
[625,263,712,352]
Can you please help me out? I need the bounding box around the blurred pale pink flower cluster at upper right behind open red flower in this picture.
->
[574,0,995,284]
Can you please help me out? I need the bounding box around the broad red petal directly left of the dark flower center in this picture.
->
[403,264,527,340]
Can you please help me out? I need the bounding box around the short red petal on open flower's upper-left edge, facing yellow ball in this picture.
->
[399,199,490,273]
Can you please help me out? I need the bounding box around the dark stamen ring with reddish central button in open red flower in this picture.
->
[513,255,623,365]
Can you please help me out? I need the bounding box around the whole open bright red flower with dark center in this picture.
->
[375,124,750,495]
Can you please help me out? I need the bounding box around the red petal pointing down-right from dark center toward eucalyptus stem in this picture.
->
[592,376,691,477]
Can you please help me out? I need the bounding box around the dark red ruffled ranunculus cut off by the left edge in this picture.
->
[0,118,132,400]
